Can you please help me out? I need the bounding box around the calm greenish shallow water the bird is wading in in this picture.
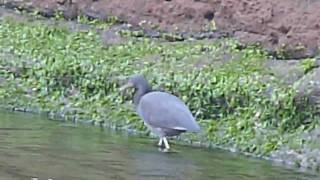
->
[0,111,319,180]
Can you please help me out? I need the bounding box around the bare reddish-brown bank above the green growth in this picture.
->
[2,0,320,59]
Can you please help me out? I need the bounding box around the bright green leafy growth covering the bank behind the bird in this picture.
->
[0,16,318,163]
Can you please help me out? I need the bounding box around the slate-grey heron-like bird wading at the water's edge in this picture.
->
[120,74,201,150]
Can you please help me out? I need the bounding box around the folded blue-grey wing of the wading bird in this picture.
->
[138,92,200,131]
